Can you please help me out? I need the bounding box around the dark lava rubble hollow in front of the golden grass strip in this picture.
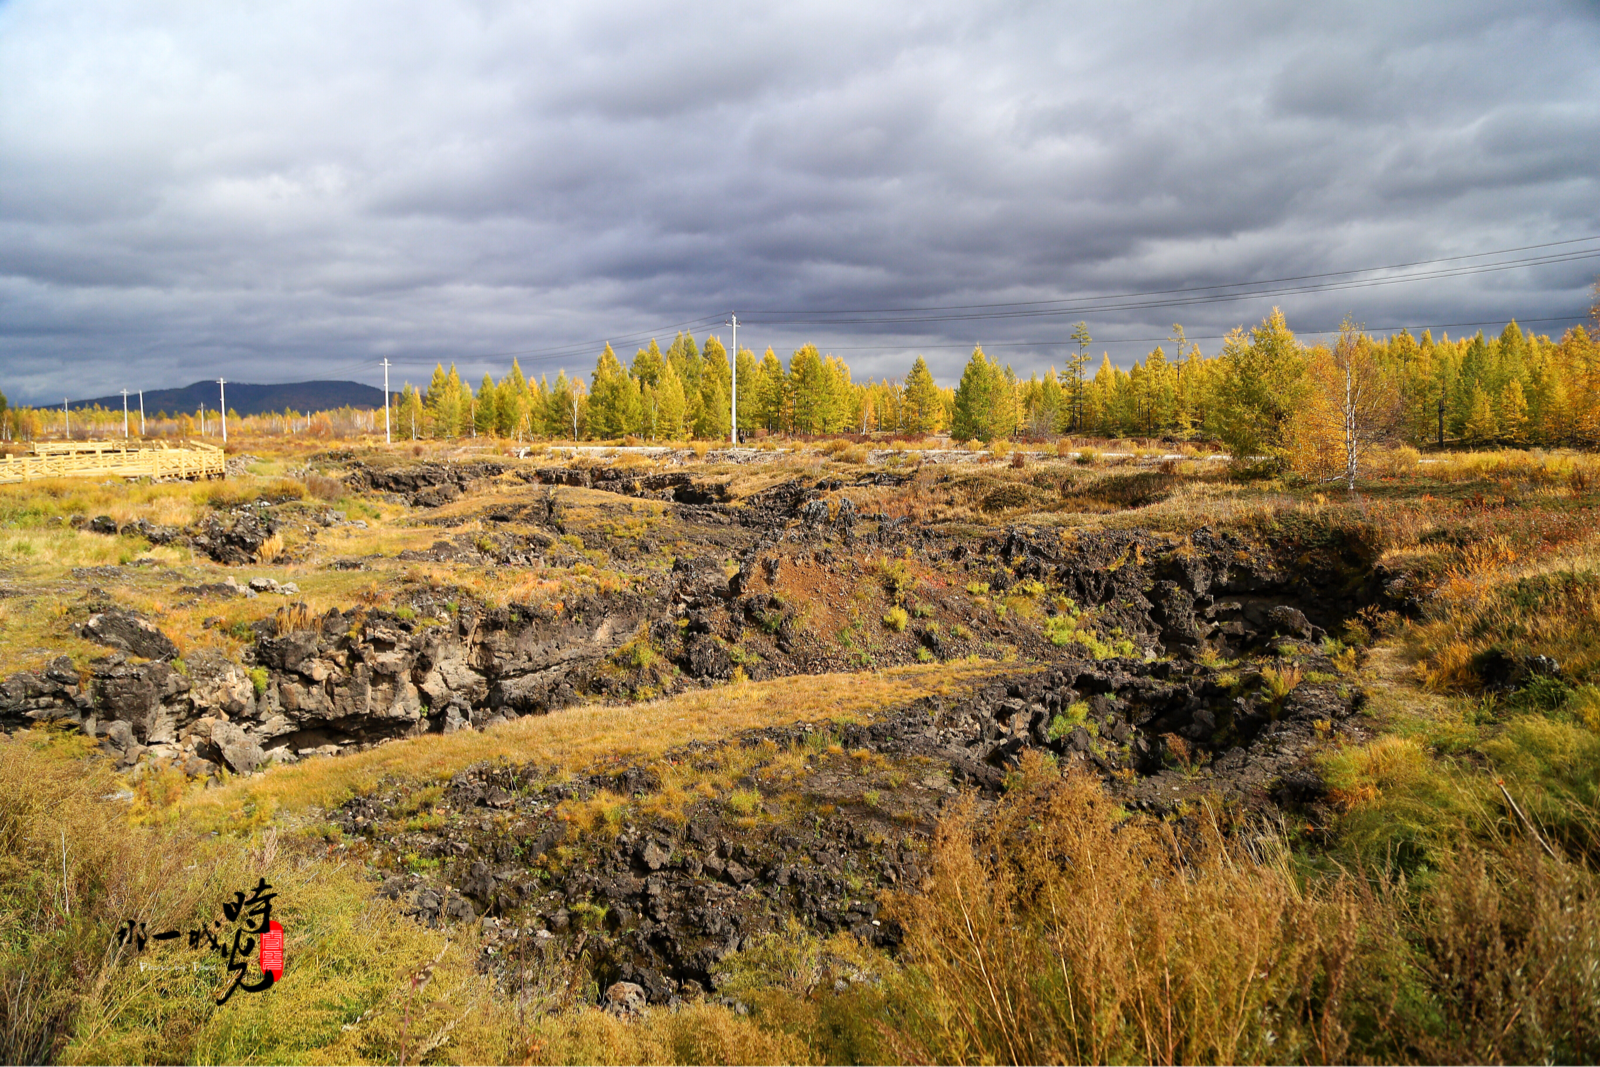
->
[336,646,1360,1003]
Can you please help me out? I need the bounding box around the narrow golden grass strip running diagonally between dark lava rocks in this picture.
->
[182,662,1014,829]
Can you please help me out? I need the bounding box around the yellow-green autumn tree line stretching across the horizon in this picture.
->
[0,299,1600,462]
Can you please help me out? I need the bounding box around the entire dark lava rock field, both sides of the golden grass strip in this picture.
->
[0,456,1406,1003]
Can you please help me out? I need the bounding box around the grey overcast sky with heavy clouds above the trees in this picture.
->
[0,0,1600,400]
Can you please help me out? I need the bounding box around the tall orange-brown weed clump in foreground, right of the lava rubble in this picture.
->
[886,760,1382,1065]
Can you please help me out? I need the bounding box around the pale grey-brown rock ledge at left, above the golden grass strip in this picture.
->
[0,609,640,774]
